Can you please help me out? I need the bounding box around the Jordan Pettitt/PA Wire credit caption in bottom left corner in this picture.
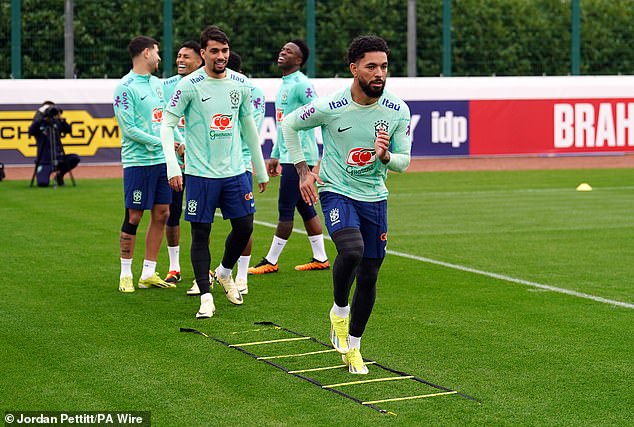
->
[4,411,152,427]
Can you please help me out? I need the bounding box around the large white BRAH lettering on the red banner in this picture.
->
[553,102,634,148]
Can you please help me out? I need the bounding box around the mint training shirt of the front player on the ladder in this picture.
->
[284,87,412,202]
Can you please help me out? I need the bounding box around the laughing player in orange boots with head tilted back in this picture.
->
[249,40,330,274]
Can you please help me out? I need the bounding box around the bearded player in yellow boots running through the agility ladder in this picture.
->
[282,36,411,374]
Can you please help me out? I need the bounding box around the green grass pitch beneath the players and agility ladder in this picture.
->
[0,169,634,426]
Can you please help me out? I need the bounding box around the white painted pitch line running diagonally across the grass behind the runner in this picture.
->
[253,220,634,309]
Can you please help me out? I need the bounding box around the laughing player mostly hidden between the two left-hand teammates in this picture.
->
[163,40,203,283]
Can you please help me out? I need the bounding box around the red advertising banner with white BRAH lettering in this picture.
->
[469,98,634,155]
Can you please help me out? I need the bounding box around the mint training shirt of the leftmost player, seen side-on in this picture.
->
[113,70,165,168]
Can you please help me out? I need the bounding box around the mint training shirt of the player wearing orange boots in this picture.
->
[271,70,319,166]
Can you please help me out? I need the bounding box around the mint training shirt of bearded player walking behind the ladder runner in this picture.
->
[166,68,253,178]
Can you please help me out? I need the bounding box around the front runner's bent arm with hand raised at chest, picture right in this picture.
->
[374,105,412,172]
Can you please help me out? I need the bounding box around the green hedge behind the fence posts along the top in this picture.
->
[0,0,634,78]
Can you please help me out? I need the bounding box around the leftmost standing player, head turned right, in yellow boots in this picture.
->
[113,36,175,292]
